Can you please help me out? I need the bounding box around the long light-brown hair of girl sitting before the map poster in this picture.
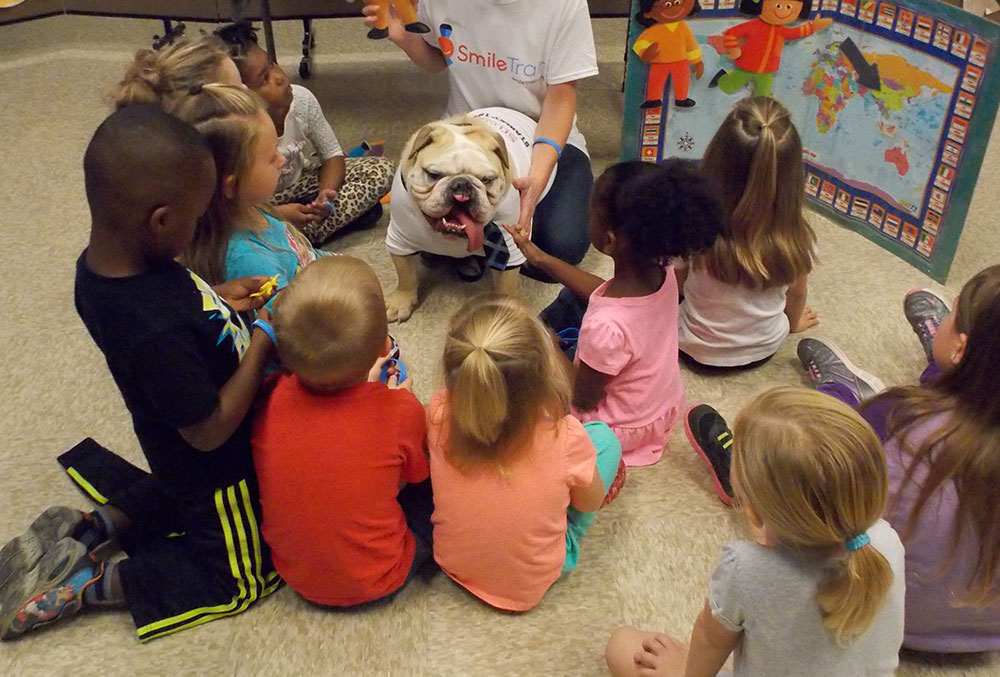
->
[692,97,816,289]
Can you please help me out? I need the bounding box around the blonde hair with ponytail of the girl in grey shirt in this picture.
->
[732,386,893,645]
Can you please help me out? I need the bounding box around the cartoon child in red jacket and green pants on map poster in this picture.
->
[708,0,833,96]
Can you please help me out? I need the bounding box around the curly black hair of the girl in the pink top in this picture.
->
[591,159,726,265]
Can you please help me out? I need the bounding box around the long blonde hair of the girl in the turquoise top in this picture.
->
[175,84,311,284]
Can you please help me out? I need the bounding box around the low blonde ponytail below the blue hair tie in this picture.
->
[816,534,892,646]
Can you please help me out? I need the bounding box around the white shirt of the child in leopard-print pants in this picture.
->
[274,85,344,193]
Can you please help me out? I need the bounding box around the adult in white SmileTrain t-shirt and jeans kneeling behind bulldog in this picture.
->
[364,0,597,270]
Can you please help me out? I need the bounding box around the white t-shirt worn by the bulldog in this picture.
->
[385,108,558,267]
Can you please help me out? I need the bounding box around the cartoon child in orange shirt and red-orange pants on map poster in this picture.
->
[632,0,705,108]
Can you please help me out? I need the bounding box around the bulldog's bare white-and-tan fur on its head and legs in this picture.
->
[385,115,518,322]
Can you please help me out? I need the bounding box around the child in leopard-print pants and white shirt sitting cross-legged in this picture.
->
[218,23,395,247]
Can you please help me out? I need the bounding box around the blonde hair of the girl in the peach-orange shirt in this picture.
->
[443,294,570,468]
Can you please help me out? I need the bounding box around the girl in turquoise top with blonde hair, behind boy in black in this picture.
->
[176,85,325,287]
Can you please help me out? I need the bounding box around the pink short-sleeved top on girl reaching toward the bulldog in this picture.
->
[573,266,684,466]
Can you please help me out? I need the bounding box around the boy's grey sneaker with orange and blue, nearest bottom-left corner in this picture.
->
[0,538,104,640]
